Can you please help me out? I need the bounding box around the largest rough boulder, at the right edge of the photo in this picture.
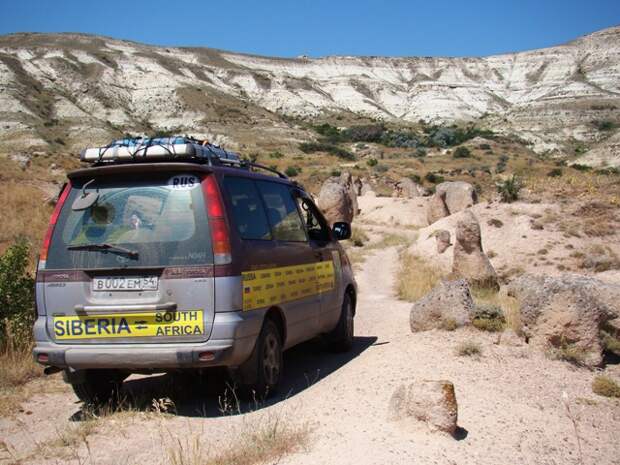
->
[508,274,620,366]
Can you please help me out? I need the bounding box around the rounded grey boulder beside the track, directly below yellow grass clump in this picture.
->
[409,279,474,333]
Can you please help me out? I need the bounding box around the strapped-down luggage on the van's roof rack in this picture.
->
[80,137,243,166]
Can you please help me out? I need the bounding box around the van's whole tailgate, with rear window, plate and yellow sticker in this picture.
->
[39,171,214,344]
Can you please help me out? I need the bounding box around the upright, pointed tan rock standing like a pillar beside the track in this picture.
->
[452,211,499,289]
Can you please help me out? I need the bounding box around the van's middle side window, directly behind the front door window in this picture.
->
[256,181,307,242]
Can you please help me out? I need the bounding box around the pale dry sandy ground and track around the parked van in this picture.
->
[0,198,620,465]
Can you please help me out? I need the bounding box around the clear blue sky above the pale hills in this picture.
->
[0,0,620,57]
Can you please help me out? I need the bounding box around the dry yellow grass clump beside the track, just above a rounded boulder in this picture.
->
[396,252,444,302]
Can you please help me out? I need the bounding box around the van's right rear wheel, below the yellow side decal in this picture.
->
[237,319,283,400]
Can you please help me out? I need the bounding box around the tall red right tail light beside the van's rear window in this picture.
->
[202,175,232,265]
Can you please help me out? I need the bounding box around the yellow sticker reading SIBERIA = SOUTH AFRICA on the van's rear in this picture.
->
[54,310,204,340]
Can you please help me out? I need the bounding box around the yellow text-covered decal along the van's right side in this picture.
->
[241,260,335,310]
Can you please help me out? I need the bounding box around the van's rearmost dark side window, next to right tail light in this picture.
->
[224,177,271,240]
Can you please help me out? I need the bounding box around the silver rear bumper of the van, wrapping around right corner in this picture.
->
[33,311,263,371]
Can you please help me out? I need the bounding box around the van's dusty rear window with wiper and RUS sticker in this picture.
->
[46,174,213,269]
